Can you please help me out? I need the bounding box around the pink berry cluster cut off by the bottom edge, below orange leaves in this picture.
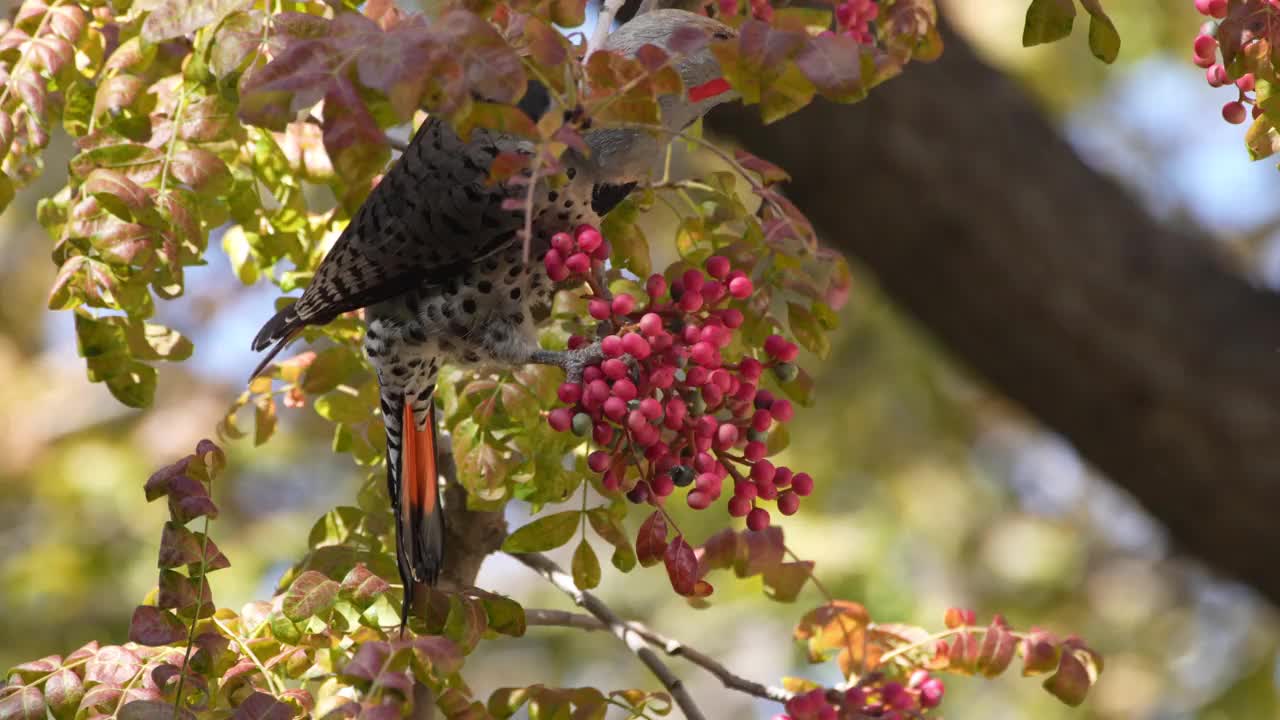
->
[773,670,945,720]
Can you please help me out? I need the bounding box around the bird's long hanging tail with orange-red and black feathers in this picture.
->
[383,389,444,628]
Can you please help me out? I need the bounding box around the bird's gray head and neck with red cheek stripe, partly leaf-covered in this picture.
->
[585,9,739,182]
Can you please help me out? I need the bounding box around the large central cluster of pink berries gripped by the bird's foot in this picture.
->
[544,225,813,530]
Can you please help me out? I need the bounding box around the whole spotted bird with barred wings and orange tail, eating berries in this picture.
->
[253,9,733,620]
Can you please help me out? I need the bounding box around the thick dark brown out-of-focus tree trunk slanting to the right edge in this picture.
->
[709,28,1280,602]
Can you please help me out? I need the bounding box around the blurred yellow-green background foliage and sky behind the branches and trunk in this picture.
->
[0,0,1280,720]
